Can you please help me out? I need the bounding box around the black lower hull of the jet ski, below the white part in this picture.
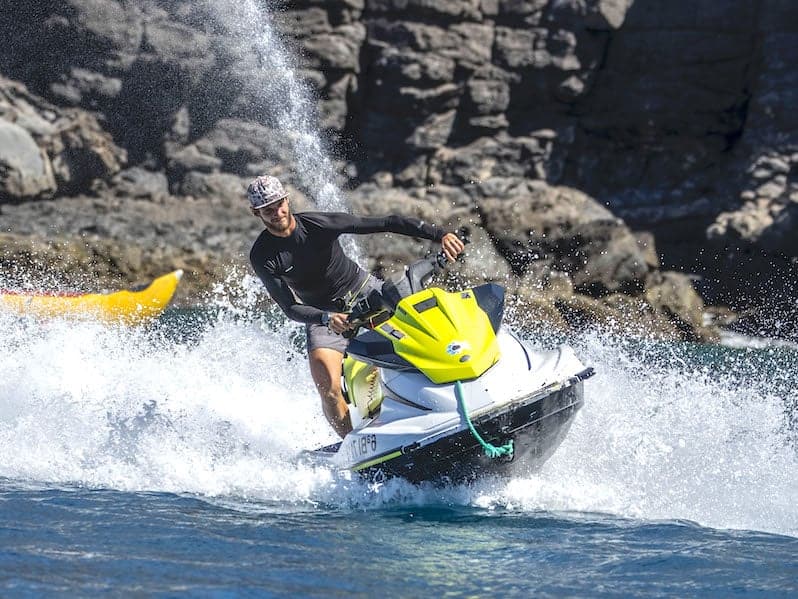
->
[359,380,592,484]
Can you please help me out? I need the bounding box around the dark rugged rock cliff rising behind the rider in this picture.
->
[0,0,798,338]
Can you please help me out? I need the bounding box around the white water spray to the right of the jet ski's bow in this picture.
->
[487,335,798,535]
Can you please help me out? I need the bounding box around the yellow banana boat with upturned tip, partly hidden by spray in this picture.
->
[0,270,183,324]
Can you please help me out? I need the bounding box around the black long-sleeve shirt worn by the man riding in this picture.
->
[249,212,445,324]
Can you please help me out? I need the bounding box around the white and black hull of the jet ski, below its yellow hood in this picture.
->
[313,329,593,483]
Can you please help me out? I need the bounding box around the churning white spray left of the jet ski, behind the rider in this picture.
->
[0,308,334,501]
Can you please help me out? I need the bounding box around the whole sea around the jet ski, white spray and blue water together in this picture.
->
[0,298,798,597]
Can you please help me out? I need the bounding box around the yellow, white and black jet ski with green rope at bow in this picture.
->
[310,254,594,484]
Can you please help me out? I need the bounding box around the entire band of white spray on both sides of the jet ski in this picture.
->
[0,314,798,535]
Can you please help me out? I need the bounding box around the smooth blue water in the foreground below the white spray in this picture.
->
[0,481,798,597]
